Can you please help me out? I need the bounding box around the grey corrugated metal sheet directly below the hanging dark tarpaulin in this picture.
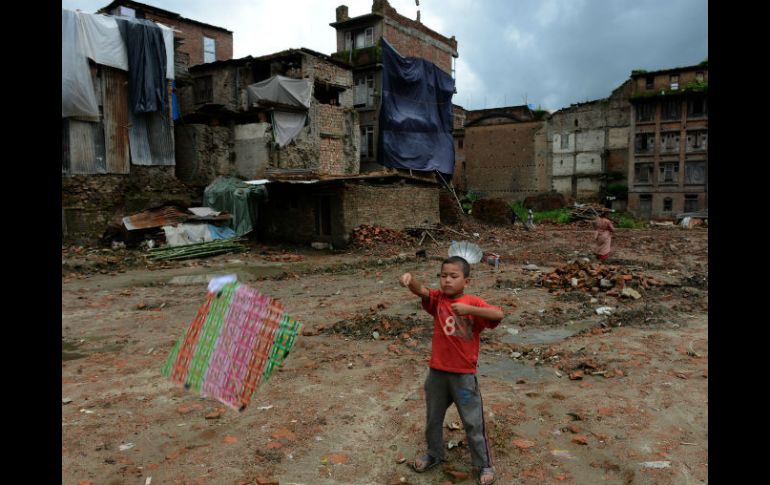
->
[128,110,174,165]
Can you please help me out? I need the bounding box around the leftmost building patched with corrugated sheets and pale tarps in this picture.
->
[62,6,224,243]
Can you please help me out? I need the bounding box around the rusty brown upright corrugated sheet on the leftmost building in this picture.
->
[101,66,130,173]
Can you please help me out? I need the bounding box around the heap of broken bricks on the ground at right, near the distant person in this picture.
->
[540,259,664,299]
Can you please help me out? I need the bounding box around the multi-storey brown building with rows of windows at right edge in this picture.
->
[628,62,708,219]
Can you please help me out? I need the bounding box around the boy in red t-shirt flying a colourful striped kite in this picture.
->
[400,256,503,485]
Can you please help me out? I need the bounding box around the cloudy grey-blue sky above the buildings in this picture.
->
[62,0,708,111]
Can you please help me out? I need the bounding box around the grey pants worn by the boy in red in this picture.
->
[425,369,492,467]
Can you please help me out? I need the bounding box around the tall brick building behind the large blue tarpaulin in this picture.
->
[330,0,458,171]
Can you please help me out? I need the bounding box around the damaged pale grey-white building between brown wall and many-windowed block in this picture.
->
[548,80,632,205]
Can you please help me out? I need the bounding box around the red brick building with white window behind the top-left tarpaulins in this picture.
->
[97,0,233,67]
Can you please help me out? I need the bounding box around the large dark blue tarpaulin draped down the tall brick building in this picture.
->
[378,39,455,175]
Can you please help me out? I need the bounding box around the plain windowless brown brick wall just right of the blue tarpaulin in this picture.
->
[464,121,550,200]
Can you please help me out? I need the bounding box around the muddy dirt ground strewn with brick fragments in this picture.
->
[62,224,708,485]
